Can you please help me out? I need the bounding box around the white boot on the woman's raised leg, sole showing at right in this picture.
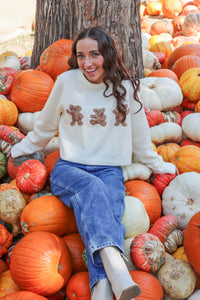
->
[100,247,141,300]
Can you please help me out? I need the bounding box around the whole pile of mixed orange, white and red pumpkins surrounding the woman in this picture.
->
[0,0,200,300]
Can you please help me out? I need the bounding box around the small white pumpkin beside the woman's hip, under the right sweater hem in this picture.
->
[122,163,152,181]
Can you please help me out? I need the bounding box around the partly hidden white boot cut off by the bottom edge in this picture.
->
[91,278,113,300]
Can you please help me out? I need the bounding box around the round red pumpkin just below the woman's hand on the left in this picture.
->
[16,158,48,194]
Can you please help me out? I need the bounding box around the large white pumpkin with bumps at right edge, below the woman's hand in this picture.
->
[162,172,200,230]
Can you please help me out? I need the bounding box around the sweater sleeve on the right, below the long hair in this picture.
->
[131,95,176,174]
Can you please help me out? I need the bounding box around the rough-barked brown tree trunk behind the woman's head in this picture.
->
[32,0,144,78]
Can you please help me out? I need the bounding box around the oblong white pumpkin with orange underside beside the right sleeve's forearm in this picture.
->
[150,122,183,145]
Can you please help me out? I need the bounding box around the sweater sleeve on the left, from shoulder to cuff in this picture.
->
[11,79,62,158]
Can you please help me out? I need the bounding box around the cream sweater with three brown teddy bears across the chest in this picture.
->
[11,69,175,173]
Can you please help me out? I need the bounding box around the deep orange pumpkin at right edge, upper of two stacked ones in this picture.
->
[168,43,200,69]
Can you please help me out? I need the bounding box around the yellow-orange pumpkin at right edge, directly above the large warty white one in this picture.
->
[171,145,200,174]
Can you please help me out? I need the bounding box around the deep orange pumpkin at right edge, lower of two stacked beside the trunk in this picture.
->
[172,55,200,78]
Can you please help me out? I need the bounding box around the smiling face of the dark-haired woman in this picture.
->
[76,37,105,83]
